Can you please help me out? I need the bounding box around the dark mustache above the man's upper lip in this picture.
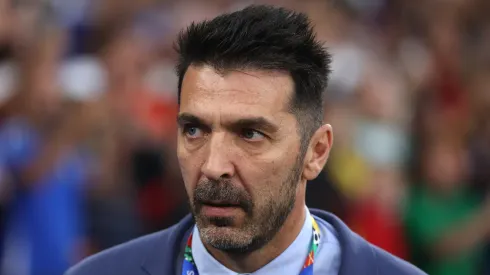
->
[193,180,253,214]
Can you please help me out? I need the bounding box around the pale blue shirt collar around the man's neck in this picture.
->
[192,206,312,275]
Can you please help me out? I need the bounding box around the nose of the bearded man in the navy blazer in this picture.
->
[201,133,235,180]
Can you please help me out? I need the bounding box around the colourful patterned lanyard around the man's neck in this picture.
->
[182,217,320,275]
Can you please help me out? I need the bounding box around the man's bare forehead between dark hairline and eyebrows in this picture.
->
[180,66,294,116]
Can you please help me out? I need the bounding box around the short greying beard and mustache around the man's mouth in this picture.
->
[191,158,302,254]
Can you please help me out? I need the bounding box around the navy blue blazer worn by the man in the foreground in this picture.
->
[65,209,426,275]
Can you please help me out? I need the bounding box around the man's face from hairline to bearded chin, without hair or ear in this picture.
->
[177,66,303,252]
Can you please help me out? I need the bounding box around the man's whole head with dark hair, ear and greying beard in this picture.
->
[177,6,332,252]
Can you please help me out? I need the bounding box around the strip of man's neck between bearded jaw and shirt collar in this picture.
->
[205,198,306,273]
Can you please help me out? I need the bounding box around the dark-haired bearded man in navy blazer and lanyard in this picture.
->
[67,6,424,275]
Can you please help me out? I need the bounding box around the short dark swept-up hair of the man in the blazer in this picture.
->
[176,5,331,149]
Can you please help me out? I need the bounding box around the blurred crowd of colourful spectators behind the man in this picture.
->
[0,0,490,275]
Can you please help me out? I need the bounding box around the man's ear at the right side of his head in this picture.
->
[303,124,333,180]
